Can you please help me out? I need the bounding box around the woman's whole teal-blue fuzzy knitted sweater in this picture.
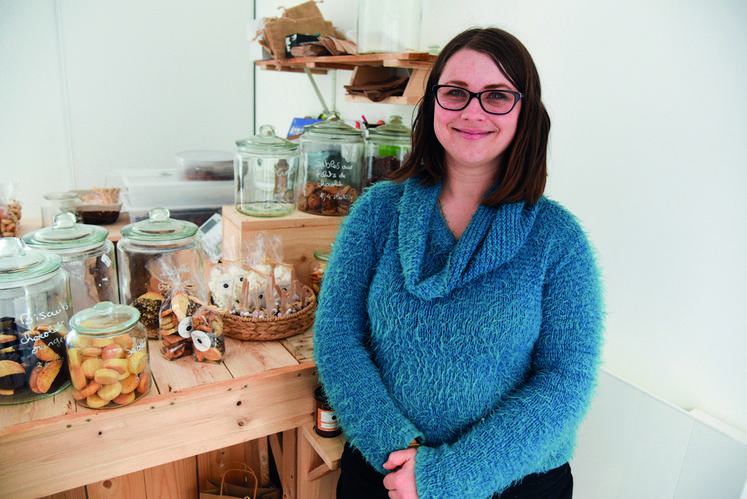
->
[314,180,603,499]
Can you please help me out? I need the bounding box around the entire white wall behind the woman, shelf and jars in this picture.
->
[0,0,747,446]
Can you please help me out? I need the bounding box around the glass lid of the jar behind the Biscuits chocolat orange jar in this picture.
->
[23,212,109,251]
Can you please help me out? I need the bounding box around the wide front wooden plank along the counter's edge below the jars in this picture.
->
[0,364,317,497]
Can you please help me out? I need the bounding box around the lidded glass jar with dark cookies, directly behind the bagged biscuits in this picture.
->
[117,208,207,338]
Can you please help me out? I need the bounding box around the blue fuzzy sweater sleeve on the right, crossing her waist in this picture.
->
[415,210,603,498]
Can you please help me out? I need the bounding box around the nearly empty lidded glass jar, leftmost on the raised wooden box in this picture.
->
[234,125,299,217]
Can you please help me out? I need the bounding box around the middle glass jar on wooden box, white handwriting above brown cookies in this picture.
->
[297,116,363,216]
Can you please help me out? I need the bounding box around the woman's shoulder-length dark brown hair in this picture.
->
[392,28,550,206]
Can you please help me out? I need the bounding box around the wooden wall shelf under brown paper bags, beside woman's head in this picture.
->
[255,52,436,105]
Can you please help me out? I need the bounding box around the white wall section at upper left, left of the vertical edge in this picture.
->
[0,0,254,217]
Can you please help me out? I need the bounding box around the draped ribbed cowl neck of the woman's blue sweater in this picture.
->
[397,179,538,300]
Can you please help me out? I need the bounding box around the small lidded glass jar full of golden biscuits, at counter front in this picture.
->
[65,301,150,409]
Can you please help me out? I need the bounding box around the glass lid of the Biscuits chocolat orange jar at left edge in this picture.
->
[0,237,62,285]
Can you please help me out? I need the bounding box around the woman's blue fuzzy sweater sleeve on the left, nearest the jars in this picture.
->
[314,185,422,472]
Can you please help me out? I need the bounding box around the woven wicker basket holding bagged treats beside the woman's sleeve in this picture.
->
[220,285,316,341]
